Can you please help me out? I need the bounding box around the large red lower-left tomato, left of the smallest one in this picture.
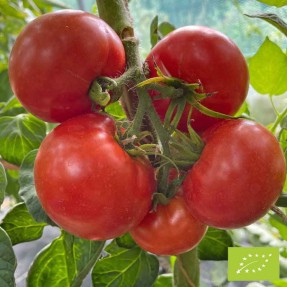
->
[34,113,156,240]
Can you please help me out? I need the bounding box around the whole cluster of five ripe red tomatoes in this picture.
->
[9,10,286,255]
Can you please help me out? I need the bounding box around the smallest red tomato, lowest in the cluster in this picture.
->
[130,196,207,255]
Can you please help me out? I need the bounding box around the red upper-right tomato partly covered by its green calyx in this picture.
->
[146,26,249,133]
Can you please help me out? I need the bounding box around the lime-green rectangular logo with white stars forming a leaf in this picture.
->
[228,247,279,281]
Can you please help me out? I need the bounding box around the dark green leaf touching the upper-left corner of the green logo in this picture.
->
[197,227,233,260]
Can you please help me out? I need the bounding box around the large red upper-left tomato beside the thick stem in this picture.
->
[9,10,125,122]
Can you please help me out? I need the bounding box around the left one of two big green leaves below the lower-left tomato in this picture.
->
[27,232,104,287]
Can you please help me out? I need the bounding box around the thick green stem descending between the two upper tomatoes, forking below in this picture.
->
[97,0,173,157]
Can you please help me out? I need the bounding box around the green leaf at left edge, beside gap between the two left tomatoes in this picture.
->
[0,114,46,165]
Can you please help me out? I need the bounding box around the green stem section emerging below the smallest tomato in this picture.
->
[174,248,200,287]
